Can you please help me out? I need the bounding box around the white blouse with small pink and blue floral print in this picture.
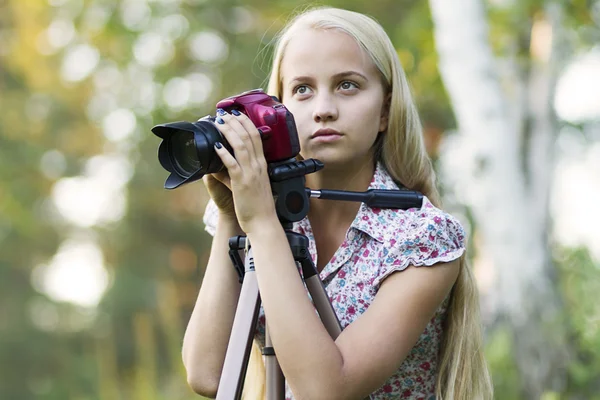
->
[204,164,465,400]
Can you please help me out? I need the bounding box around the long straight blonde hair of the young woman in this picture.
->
[247,7,493,400]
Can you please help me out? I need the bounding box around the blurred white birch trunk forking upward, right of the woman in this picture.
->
[430,0,568,399]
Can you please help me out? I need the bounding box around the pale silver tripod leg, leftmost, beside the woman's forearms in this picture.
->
[217,249,260,400]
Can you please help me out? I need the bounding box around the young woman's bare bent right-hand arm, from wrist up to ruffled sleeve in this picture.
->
[248,221,458,400]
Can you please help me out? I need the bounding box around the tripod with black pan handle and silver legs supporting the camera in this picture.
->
[217,159,423,400]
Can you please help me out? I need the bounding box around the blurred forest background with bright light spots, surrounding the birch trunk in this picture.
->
[0,0,600,400]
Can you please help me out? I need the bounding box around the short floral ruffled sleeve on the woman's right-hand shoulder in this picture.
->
[373,203,465,287]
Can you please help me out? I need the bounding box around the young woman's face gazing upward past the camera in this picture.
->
[281,28,387,167]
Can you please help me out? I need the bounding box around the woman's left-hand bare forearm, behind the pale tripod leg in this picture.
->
[183,215,242,397]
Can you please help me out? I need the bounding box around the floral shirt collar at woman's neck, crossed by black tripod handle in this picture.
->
[350,162,399,243]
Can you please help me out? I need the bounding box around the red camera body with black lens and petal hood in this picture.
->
[152,89,300,189]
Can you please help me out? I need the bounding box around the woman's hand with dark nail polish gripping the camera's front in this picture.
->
[215,110,277,234]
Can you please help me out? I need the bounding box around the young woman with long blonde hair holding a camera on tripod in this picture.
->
[183,8,492,400]
